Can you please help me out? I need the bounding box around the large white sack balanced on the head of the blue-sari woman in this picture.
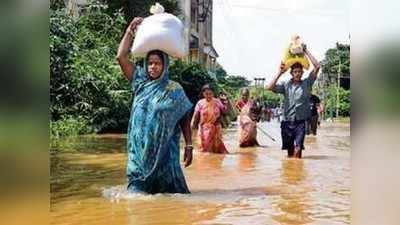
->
[131,3,185,58]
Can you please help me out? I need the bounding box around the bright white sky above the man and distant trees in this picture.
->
[213,0,350,82]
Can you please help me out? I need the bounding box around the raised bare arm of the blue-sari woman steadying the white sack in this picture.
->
[117,17,143,81]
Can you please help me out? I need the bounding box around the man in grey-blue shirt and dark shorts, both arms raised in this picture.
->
[268,45,320,158]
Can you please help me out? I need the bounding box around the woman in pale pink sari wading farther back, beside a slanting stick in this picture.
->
[236,89,261,147]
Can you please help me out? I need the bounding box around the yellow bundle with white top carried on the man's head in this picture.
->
[282,35,310,70]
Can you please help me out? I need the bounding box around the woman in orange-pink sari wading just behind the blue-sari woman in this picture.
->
[192,84,229,154]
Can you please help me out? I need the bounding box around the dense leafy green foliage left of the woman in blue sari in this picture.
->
[50,3,132,132]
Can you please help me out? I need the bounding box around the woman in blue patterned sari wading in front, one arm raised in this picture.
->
[117,18,193,194]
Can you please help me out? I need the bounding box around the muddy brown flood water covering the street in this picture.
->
[50,122,350,225]
